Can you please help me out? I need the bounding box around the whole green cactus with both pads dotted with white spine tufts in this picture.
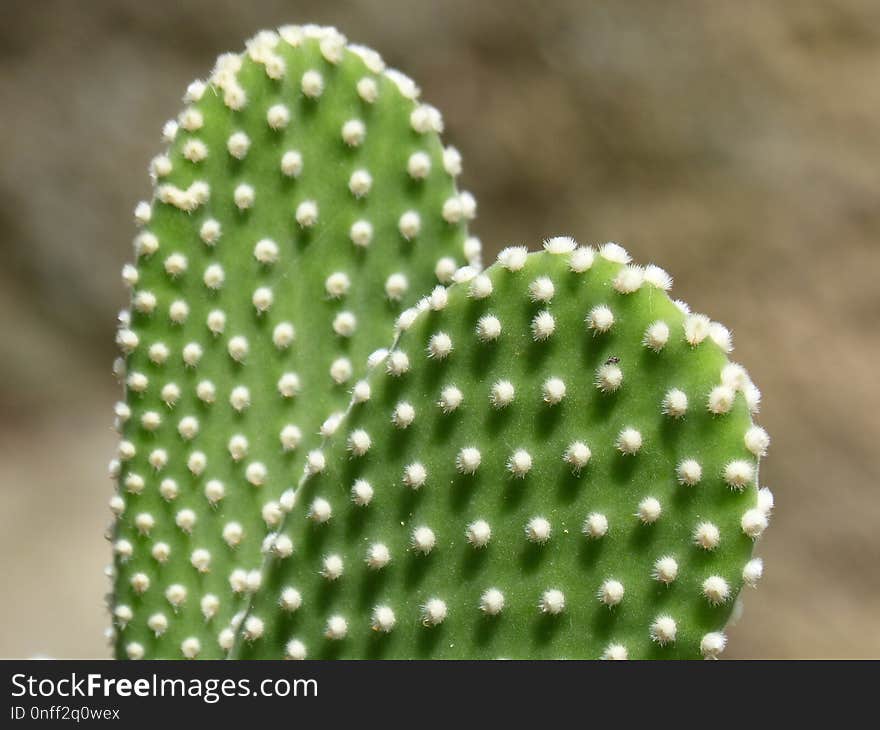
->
[110,26,772,659]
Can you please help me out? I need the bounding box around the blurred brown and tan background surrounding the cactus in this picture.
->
[0,0,880,658]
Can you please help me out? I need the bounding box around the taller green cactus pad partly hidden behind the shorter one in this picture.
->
[111,26,479,658]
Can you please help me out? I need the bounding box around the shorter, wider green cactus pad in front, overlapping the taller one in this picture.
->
[233,239,771,659]
